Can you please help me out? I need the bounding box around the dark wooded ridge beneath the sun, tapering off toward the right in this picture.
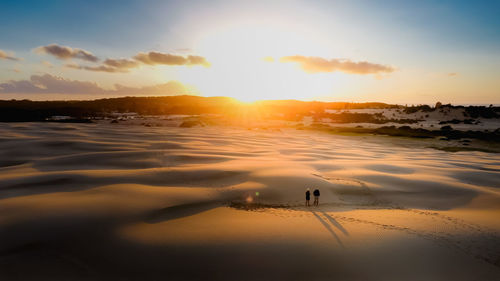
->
[0,96,395,122]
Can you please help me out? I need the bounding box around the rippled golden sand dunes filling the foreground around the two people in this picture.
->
[0,123,500,280]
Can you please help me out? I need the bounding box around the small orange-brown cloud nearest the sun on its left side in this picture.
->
[134,52,210,67]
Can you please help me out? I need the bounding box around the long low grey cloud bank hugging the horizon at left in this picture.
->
[0,74,195,96]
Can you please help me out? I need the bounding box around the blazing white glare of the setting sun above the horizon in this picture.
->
[178,23,340,102]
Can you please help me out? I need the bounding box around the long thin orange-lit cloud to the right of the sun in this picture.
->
[280,55,396,74]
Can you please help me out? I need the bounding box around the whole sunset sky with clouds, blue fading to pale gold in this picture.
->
[0,0,500,104]
